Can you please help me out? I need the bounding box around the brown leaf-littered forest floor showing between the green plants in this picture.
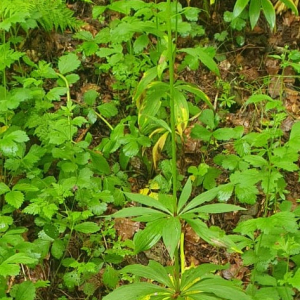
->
[16,1,300,299]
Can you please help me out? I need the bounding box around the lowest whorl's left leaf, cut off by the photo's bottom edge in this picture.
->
[103,282,171,300]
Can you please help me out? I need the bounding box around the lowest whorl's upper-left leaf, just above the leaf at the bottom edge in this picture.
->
[121,260,174,288]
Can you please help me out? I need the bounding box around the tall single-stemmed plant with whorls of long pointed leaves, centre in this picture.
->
[104,1,251,300]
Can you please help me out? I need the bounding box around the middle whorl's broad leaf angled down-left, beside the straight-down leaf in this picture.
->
[133,219,167,254]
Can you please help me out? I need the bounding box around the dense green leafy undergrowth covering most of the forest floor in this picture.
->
[0,0,300,300]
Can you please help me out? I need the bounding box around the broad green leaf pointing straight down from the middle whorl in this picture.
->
[162,217,181,259]
